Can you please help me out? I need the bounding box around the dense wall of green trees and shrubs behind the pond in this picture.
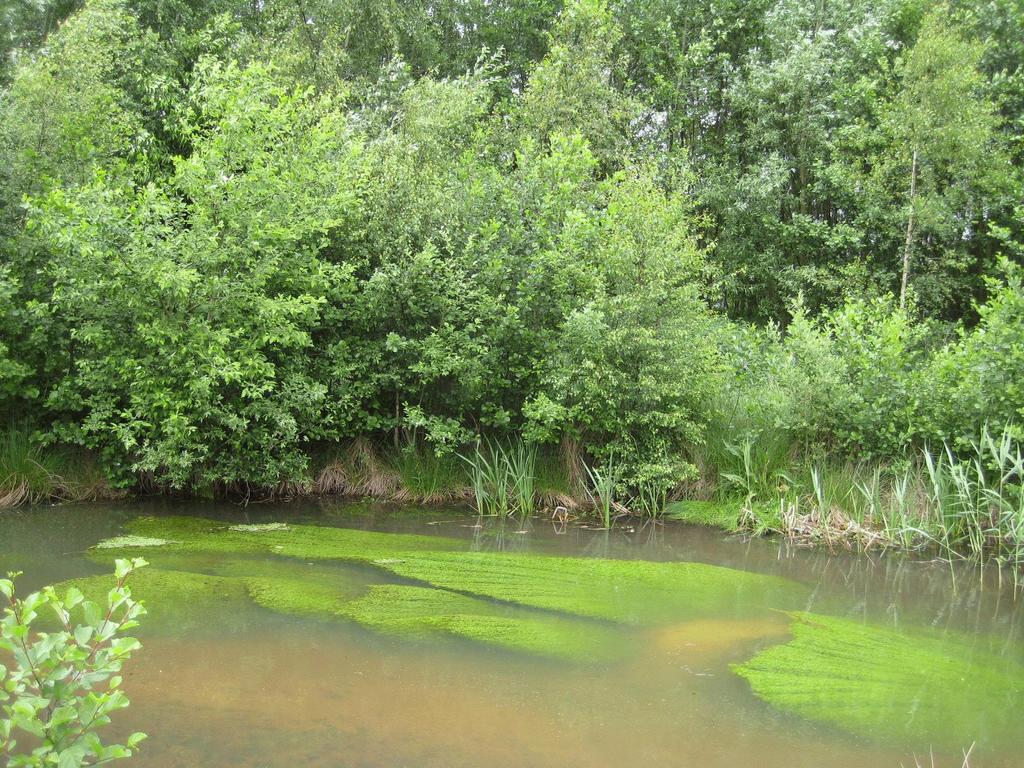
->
[0,0,1024,507]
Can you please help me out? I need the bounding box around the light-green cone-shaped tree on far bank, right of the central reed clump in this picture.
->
[524,162,718,493]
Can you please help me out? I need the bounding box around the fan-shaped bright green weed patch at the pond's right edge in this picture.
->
[733,613,1024,749]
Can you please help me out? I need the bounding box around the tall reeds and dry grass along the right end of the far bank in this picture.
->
[722,427,1024,578]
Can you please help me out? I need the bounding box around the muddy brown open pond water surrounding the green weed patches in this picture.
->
[0,503,1024,768]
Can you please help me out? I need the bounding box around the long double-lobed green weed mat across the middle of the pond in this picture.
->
[76,517,805,659]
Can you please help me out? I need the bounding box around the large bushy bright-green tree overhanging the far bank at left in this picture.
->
[32,61,359,487]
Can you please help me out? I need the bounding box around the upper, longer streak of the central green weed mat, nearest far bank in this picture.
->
[95,517,804,624]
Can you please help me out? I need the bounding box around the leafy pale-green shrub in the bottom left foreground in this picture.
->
[0,559,146,768]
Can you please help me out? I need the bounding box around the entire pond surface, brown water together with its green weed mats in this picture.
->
[0,503,1024,768]
